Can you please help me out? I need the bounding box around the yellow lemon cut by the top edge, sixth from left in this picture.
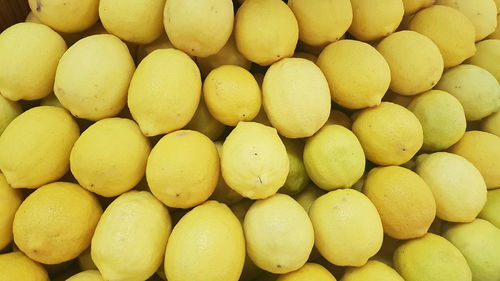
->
[349,0,404,41]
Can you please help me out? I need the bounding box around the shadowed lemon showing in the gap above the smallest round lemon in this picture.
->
[196,35,252,77]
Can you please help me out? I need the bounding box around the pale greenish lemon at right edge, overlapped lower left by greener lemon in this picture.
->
[436,64,500,121]
